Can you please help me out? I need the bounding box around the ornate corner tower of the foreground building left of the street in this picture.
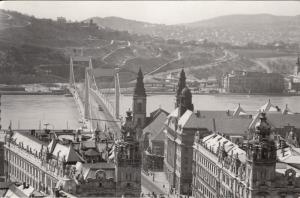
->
[114,111,141,197]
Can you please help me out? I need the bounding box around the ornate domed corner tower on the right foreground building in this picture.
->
[246,113,276,197]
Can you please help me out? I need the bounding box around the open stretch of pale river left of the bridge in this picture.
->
[1,95,80,129]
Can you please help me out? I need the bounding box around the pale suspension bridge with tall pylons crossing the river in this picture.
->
[68,56,121,137]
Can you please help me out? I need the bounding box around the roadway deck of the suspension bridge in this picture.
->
[77,84,121,137]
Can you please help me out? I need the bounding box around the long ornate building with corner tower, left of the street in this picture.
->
[4,112,141,197]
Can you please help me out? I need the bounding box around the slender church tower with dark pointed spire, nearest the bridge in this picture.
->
[132,68,147,131]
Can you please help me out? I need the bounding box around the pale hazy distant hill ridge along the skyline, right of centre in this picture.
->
[85,14,300,45]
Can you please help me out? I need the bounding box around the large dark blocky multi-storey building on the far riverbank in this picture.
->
[223,71,284,94]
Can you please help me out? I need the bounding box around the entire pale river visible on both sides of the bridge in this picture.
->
[2,95,300,129]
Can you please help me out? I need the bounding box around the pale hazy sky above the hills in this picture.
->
[0,1,300,24]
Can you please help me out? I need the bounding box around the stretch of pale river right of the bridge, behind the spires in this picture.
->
[120,95,300,117]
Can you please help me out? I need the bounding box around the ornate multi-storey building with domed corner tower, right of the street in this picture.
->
[191,113,300,198]
